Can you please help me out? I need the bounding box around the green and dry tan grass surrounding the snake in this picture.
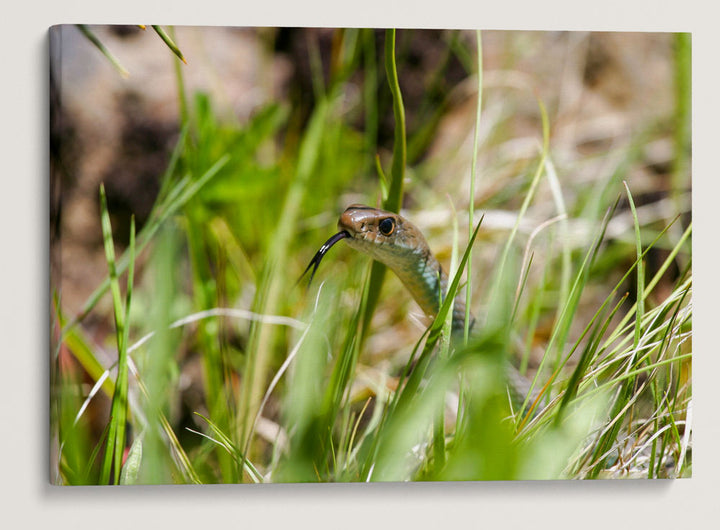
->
[51,29,692,484]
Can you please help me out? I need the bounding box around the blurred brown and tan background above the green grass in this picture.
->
[51,26,690,312]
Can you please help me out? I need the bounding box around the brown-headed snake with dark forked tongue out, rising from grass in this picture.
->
[301,204,534,414]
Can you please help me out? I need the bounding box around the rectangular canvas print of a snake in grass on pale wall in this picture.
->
[49,24,692,485]
